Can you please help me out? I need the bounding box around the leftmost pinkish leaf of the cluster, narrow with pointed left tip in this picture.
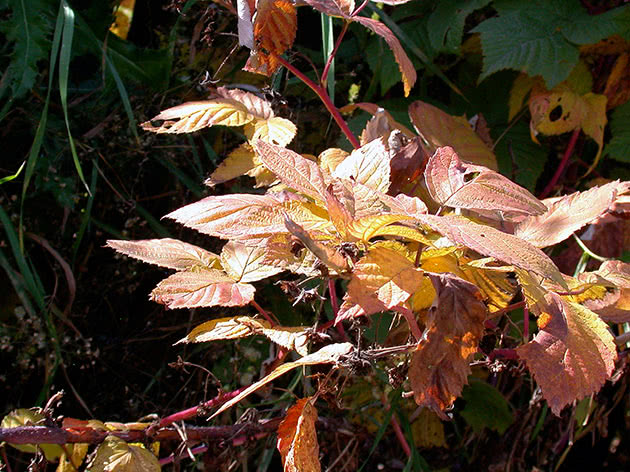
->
[107,238,221,270]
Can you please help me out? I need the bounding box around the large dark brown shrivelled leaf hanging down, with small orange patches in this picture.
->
[409,274,488,419]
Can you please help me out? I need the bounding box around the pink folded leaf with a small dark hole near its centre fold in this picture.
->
[424,146,547,215]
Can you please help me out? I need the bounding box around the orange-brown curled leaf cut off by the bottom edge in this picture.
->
[278,397,321,472]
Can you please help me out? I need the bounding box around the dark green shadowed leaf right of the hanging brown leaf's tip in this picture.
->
[460,379,514,434]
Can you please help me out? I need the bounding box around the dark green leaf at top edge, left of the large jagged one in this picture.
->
[427,0,490,54]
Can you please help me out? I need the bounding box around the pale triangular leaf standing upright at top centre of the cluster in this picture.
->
[333,138,391,193]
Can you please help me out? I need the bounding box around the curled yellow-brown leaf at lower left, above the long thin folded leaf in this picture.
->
[175,316,309,356]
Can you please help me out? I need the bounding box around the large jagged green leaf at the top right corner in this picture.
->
[473,0,628,89]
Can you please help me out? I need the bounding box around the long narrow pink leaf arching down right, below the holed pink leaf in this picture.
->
[418,215,566,288]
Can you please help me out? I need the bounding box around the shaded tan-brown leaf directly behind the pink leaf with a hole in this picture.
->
[409,101,497,170]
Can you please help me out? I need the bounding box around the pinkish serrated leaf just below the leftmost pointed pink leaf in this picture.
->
[151,270,256,308]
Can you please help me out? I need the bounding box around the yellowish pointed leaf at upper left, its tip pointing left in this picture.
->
[141,98,254,133]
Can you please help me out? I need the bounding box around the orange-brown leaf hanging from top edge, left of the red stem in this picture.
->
[245,0,297,76]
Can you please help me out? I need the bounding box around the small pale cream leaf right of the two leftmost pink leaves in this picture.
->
[221,241,282,282]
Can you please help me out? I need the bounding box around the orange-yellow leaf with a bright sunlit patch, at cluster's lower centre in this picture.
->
[335,246,423,323]
